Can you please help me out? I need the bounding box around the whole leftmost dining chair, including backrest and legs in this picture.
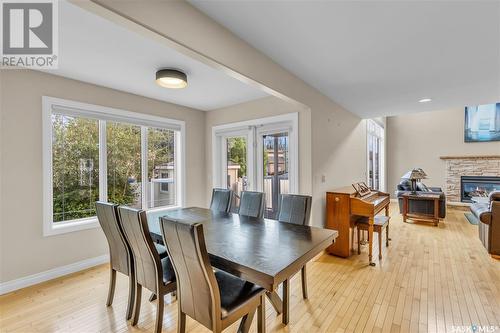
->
[95,201,135,320]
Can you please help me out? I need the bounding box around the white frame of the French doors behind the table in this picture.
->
[212,112,300,194]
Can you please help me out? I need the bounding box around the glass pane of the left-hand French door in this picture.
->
[225,137,248,211]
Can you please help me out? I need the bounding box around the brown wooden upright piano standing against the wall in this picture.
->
[326,186,390,265]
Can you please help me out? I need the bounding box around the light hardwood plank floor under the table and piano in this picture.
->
[0,205,500,332]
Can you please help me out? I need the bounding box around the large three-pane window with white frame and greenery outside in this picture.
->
[43,97,184,235]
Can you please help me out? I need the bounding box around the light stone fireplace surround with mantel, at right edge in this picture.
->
[441,155,500,204]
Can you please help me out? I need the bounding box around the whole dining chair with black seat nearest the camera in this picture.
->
[160,217,266,333]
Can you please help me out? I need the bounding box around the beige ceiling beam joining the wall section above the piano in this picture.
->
[93,0,366,225]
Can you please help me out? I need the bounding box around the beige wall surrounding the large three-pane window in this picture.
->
[0,70,206,282]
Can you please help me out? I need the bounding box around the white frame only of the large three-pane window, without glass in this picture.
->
[42,96,186,236]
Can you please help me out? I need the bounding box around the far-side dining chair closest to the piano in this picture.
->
[278,194,312,299]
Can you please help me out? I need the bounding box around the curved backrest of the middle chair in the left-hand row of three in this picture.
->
[118,206,163,294]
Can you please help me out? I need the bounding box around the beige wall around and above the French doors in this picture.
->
[205,97,312,200]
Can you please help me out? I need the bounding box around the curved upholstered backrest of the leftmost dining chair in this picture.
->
[95,201,132,275]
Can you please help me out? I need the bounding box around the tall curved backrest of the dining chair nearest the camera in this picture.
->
[160,217,221,329]
